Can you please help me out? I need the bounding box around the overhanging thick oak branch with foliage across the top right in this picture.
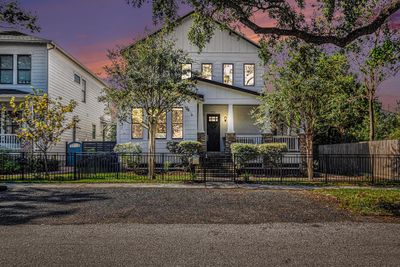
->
[127,0,400,48]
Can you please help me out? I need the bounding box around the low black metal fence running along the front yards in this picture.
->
[0,153,400,184]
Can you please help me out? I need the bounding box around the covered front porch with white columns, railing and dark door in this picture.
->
[197,102,300,152]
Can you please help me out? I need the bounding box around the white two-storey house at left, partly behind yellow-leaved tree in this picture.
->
[0,31,106,152]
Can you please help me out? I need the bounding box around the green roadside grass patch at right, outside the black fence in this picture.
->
[313,188,400,217]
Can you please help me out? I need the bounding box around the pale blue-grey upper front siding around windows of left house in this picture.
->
[0,43,48,92]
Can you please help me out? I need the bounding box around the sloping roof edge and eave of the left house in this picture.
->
[0,31,107,87]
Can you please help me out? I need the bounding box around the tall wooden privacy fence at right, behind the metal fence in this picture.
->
[318,140,400,179]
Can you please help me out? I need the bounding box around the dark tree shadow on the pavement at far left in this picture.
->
[0,188,107,225]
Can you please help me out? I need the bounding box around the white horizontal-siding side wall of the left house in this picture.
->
[49,49,106,152]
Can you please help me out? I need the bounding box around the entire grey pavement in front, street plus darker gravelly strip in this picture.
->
[0,187,400,266]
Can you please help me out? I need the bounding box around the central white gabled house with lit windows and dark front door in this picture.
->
[117,13,299,152]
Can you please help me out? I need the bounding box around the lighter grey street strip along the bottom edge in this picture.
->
[0,223,400,266]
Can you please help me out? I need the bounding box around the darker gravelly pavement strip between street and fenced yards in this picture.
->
[0,187,356,225]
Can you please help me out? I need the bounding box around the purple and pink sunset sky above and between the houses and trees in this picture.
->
[20,0,400,109]
